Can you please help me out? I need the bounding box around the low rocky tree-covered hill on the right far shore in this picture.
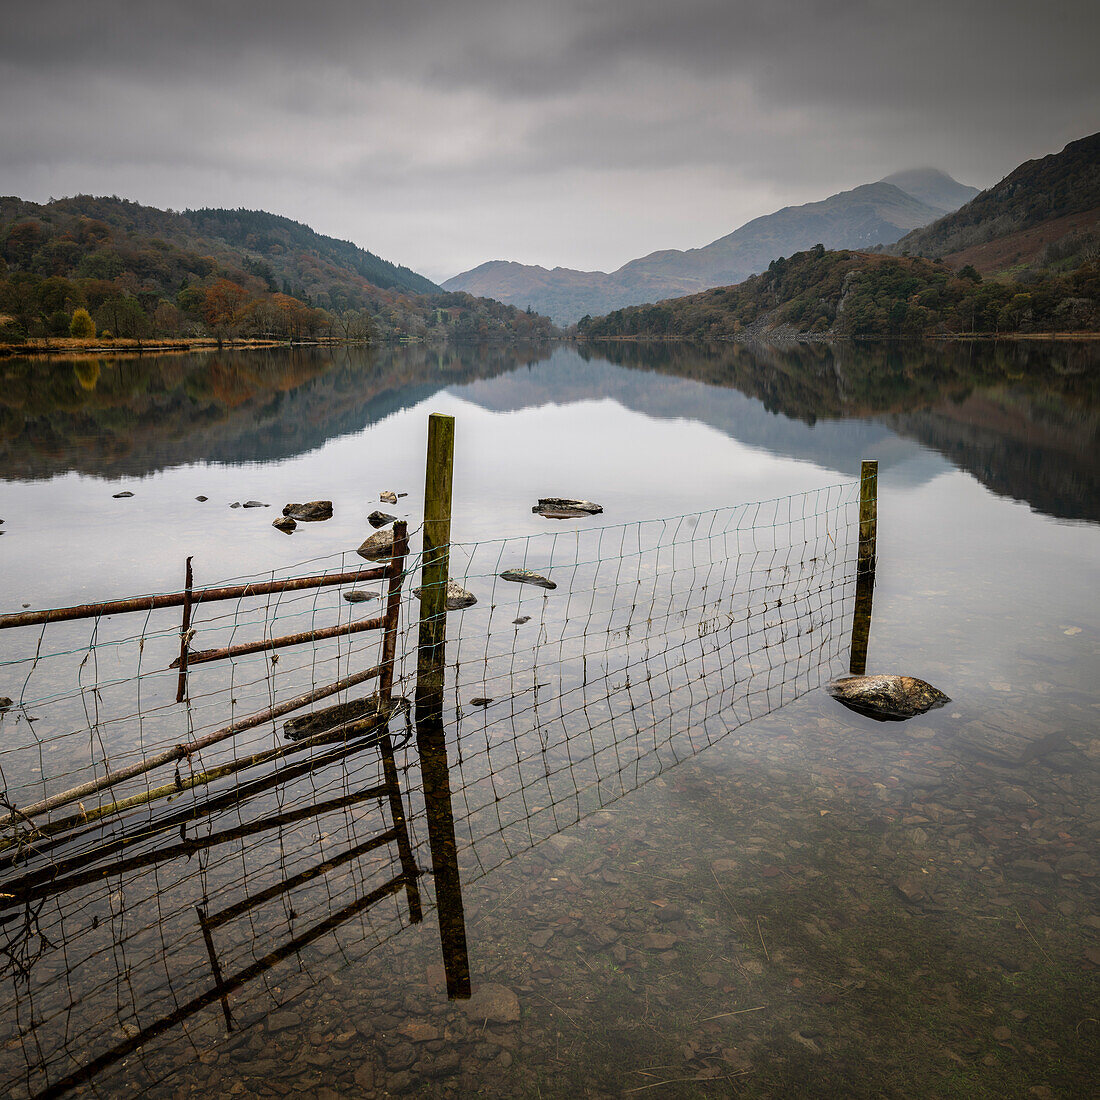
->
[578,245,1100,340]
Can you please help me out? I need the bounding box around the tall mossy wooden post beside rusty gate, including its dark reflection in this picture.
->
[416,413,470,997]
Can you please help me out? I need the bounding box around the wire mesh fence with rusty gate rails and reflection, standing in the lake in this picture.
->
[0,415,873,1096]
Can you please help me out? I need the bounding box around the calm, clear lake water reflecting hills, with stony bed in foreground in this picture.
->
[0,343,1100,1098]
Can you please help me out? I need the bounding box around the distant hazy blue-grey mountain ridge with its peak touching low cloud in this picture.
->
[443,169,977,325]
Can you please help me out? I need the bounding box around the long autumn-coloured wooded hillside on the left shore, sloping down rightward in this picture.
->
[0,196,553,343]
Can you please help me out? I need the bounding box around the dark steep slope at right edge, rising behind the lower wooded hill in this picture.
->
[887,133,1100,274]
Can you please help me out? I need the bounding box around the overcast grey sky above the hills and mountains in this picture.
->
[0,0,1100,279]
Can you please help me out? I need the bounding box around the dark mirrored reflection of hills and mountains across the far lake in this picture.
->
[0,342,1100,520]
